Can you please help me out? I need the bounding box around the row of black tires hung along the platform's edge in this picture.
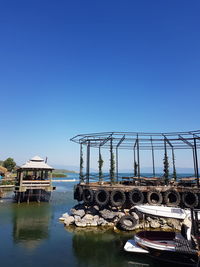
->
[74,185,199,208]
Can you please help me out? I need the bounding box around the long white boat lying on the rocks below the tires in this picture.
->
[134,205,190,220]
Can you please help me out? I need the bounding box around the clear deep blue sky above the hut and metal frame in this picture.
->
[0,0,200,170]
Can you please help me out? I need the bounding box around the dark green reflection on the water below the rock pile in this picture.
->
[68,227,153,267]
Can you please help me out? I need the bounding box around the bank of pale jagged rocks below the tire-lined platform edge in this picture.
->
[60,204,183,231]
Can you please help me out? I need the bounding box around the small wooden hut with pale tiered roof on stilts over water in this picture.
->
[15,156,55,203]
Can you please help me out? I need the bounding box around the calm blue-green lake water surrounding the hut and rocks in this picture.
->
[0,174,164,267]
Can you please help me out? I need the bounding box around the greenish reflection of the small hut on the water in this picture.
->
[13,203,51,250]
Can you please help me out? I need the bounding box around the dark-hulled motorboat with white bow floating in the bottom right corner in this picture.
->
[124,210,200,266]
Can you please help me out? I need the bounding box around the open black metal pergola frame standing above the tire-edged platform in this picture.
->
[71,130,200,187]
